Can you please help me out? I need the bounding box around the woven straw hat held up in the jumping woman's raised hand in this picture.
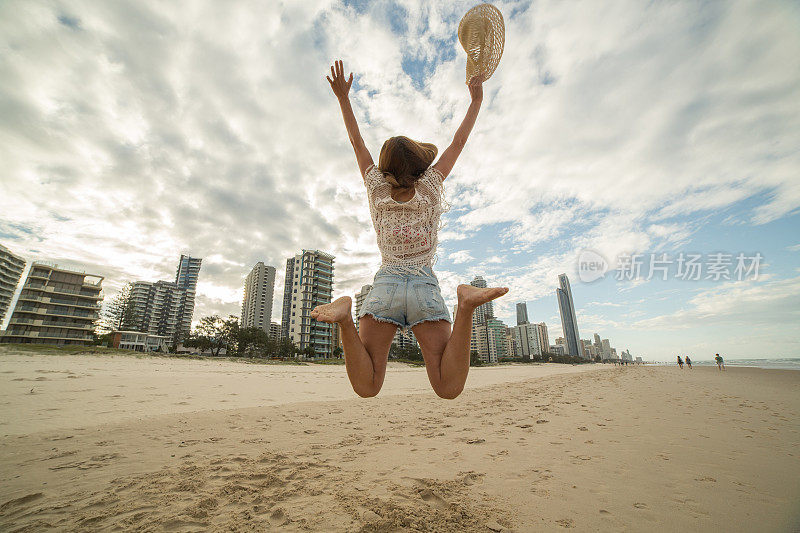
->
[458,4,506,83]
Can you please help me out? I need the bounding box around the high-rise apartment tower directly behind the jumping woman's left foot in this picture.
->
[281,250,335,357]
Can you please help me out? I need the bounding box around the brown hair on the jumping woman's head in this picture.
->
[378,136,439,189]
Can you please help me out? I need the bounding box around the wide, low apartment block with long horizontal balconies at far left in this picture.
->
[3,262,103,345]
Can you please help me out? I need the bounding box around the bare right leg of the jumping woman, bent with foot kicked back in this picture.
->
[411,285,508,399]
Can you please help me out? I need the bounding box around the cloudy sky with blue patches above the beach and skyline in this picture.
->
[0,0,800,359]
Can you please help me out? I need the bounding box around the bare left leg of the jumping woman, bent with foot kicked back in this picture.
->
[311,296,397,398]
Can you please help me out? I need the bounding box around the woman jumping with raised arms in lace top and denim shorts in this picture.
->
[311,60,508,399]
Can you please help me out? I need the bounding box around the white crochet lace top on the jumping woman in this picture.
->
[364,165,448,267]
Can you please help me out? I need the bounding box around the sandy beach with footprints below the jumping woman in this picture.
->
[0,353,800,531]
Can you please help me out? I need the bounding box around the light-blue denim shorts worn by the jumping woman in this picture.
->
[358,266,452,328]
